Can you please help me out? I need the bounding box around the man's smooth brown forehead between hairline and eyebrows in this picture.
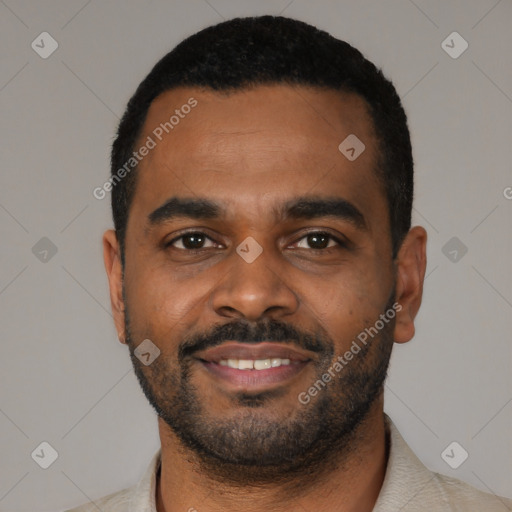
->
[128,85,383,226]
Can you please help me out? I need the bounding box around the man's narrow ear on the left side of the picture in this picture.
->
[103,229,126,343]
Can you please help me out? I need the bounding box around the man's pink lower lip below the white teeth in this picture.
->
[201,361,308,390]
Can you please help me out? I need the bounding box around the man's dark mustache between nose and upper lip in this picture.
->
[178,320,333,361]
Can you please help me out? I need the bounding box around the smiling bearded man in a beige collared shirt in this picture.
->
[69,16,512,512]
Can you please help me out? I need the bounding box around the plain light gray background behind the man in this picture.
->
[0,0,512,512]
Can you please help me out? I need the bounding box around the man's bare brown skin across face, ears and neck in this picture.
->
[103,85,426,512]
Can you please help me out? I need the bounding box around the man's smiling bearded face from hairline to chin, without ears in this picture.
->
[112,86,396,472]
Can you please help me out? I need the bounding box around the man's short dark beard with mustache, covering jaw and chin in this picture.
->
[125,291,395,485]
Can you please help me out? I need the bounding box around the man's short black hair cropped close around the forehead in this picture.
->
[111,16,413,263]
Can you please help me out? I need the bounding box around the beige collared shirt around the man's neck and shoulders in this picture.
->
[67,416,512,512]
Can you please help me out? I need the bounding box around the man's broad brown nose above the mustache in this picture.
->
[210,239,299,321]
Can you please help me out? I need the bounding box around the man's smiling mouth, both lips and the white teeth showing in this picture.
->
[195,341,313,392]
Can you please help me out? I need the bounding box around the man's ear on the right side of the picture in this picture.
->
[394,226,427,343]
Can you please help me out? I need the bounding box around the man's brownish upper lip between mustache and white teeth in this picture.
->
[195,341,311,363]
